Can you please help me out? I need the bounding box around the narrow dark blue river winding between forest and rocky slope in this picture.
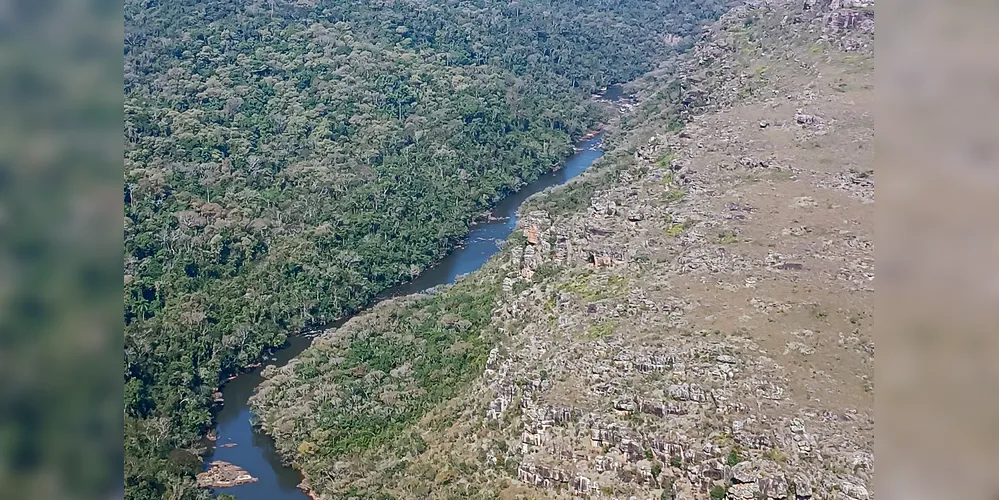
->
[208,87,620,500]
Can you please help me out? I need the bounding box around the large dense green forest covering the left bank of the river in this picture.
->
[123,0,725,499]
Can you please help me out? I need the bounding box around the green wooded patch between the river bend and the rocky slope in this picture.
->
[251,266,500,492]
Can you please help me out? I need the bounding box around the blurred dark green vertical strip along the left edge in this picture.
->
[0,0,123,499]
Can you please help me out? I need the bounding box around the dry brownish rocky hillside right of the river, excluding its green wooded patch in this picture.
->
[254,0,874,500]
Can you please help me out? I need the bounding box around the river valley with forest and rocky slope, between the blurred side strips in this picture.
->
[124,0,874,500]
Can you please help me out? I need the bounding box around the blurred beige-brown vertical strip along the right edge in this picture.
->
[875,0,999,499]
